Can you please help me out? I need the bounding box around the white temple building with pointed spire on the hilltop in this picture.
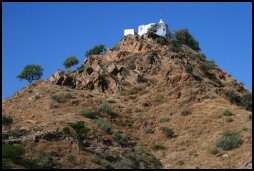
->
[124,19,173,37]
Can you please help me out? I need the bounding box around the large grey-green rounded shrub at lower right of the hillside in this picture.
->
[215,131,242,150]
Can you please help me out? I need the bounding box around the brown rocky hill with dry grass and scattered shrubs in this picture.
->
[2,35,252,168]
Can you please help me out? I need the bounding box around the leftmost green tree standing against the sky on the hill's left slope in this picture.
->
[17,64,43,83]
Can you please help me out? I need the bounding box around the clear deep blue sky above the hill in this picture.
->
[2,2,252,98]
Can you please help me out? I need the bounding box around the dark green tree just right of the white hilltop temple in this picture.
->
[176,29,201,51]
